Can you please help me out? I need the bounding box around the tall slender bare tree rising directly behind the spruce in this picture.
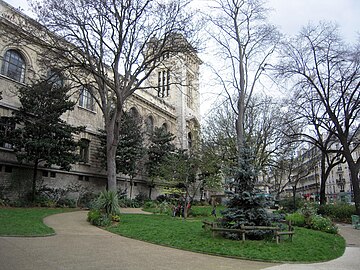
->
[205,0,280,162]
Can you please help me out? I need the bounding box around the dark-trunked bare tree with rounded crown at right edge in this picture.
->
[277,23,360,214]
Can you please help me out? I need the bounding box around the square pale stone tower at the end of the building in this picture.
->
[149,47,202,149]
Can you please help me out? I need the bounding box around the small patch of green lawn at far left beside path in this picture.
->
[0,208,73,236]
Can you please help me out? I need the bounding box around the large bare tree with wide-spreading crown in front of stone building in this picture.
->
[9,0,195,190]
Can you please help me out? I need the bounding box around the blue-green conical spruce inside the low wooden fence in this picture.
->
[220,149,271,239]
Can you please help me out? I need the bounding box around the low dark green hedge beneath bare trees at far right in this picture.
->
[318,203,356,223]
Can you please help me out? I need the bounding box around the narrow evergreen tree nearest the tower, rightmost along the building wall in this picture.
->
[146,127,175,198]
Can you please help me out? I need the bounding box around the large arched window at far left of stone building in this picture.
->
[1,50,26,82]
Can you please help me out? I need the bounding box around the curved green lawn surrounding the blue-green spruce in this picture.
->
[107,214,345,262]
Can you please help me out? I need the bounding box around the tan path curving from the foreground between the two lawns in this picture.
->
[0,211,275,270]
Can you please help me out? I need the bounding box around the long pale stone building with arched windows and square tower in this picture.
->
[0,0,201,200]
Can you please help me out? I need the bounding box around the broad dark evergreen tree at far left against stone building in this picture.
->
[12,80,83,200]
